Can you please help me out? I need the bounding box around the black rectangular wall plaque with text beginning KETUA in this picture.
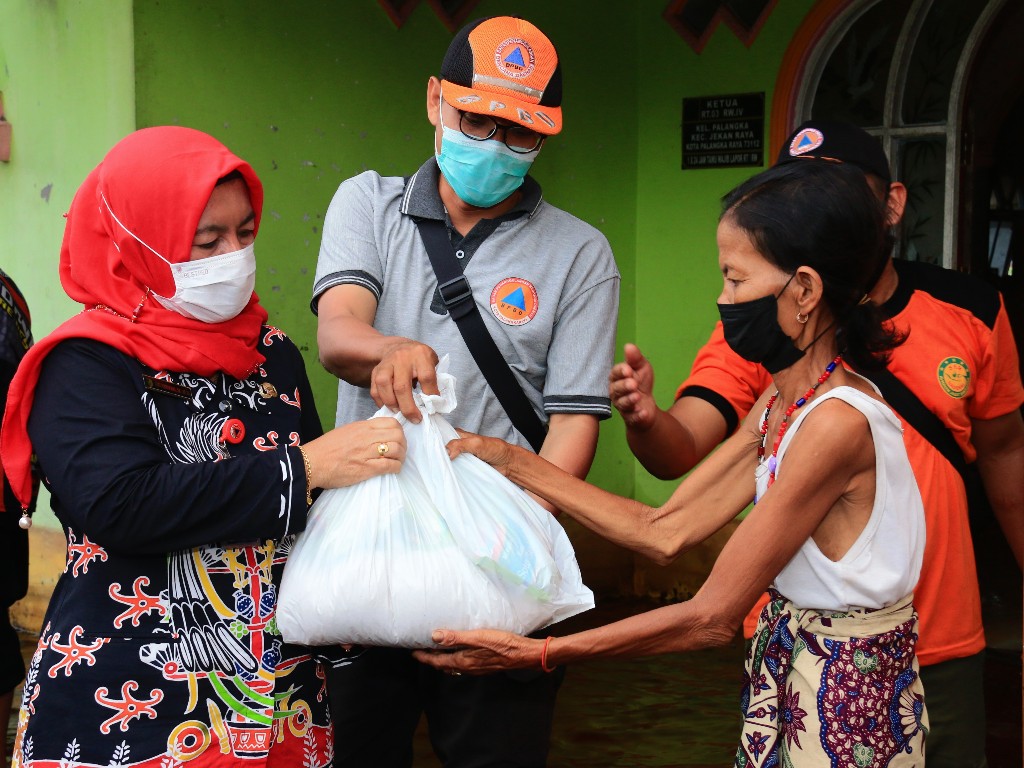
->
[683,92,765,171]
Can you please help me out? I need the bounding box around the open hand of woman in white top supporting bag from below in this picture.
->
[413,630,544,675]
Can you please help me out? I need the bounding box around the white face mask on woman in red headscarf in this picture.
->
[153,243,256,323]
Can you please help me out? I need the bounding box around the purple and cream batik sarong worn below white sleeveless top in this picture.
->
[734,590,928,768]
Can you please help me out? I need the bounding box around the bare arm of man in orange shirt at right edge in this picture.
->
[971,411,1024,567]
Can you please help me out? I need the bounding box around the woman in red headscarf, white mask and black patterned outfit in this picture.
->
[2,127,404,768]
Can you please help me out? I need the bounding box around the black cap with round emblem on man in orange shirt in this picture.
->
[775,120,892,184]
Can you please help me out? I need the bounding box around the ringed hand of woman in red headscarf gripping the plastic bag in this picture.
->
[302,417,407,488]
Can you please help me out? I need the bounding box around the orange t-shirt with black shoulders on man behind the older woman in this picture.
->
[677,261,1024,665]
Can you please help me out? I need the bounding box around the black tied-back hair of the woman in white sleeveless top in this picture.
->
[721,161,904,371]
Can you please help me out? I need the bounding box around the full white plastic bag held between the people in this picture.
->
[278,357,594,648]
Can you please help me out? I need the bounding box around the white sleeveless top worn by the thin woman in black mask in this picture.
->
[756,385,925,611]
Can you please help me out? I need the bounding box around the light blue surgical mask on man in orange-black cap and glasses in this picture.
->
[434,125,541,208]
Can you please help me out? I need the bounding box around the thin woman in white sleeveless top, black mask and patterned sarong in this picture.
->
[417,163,927,768]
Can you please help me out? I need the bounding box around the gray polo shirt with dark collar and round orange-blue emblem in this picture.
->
[311,158,620,447]
